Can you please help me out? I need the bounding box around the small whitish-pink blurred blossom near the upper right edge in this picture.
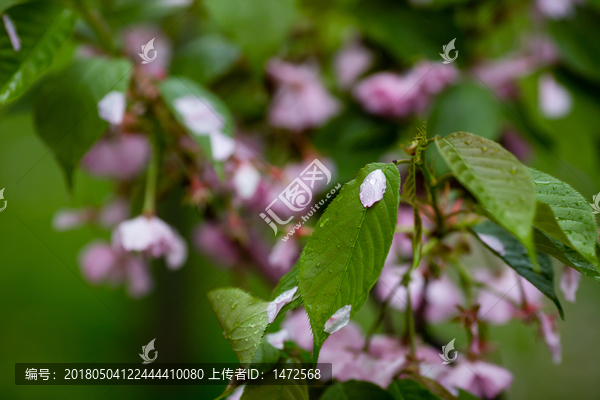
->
[538,74,573,119]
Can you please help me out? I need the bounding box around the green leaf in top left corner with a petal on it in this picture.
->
[0,1,75,104]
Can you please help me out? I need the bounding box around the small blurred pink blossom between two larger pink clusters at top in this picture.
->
[334,42,373,88]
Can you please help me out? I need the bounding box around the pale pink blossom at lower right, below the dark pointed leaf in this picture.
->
[474,267,542,324]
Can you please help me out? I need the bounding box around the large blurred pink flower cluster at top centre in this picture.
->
[267,59,340,132]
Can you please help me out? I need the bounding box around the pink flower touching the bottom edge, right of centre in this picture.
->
[439,361,513,399]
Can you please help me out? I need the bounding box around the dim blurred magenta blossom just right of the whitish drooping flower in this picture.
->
[194,222,241,267]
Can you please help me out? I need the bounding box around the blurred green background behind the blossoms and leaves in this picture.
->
[0,0,600,400]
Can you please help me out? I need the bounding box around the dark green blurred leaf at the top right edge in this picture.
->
[548,8,600,82]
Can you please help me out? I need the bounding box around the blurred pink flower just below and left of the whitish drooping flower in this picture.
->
[79,243,153,297]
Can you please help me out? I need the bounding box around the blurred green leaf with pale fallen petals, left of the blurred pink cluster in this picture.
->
[159,76,235,158]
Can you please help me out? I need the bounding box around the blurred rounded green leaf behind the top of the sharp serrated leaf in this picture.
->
[427,83,502,140]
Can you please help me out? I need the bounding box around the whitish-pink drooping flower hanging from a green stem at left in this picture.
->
[113,215,187,269]
